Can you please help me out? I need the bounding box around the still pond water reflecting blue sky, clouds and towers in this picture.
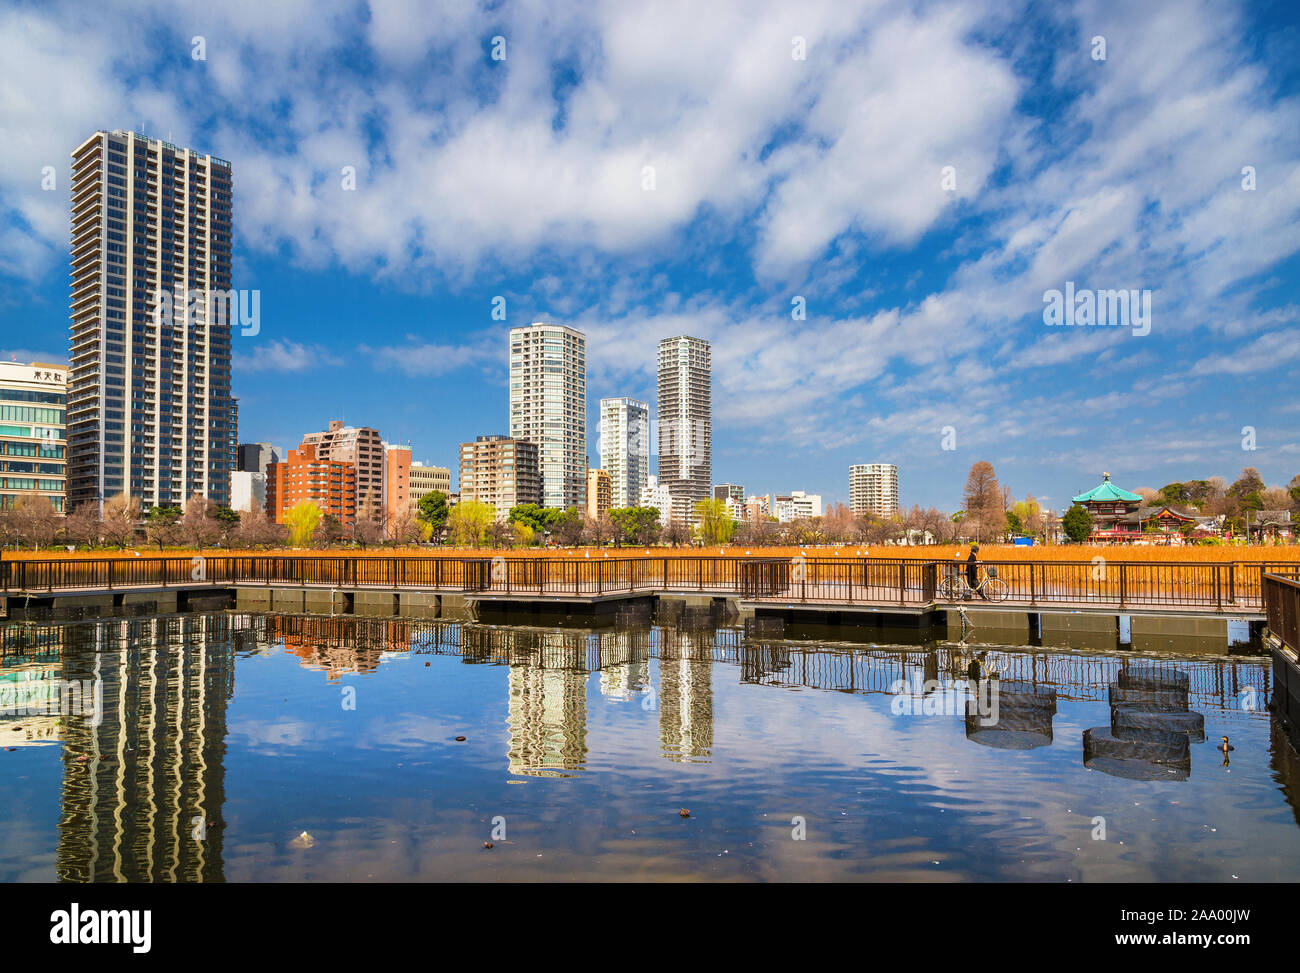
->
[0,613,1300,882]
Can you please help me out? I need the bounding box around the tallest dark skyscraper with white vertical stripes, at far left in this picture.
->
[68,131,238,509]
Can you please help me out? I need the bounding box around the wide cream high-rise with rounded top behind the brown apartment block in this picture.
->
[510,323,586,507]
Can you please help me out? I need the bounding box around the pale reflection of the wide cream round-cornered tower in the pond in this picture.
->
[507,632,588,777]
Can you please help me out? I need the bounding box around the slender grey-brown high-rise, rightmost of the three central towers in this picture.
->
[659,334,714,522]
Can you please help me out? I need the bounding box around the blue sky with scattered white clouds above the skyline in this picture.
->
[0,0,1300,509]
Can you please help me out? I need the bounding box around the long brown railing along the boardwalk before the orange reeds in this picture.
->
[0,554,1300,611]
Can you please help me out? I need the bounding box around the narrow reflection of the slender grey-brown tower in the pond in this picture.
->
[659,630,714,761]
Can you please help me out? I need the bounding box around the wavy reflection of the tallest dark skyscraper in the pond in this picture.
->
[57,615,234,882]
